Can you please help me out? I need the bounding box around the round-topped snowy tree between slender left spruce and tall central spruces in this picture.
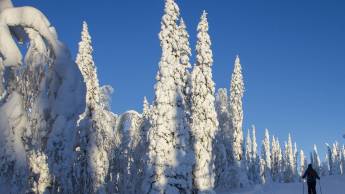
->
[108,111,147,194]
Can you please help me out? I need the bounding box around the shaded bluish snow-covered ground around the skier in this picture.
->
[217,176,345,194]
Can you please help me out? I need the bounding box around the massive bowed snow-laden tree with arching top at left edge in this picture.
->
[0,0,85,193]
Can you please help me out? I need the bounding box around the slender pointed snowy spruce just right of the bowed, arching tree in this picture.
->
[73,22,114,193]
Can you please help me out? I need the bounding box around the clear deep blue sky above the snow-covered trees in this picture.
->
[13,0,345,157]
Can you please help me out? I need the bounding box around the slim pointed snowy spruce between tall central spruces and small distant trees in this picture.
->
[230,56,244,161]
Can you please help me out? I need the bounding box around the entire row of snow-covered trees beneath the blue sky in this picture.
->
[0,0,345,194]
